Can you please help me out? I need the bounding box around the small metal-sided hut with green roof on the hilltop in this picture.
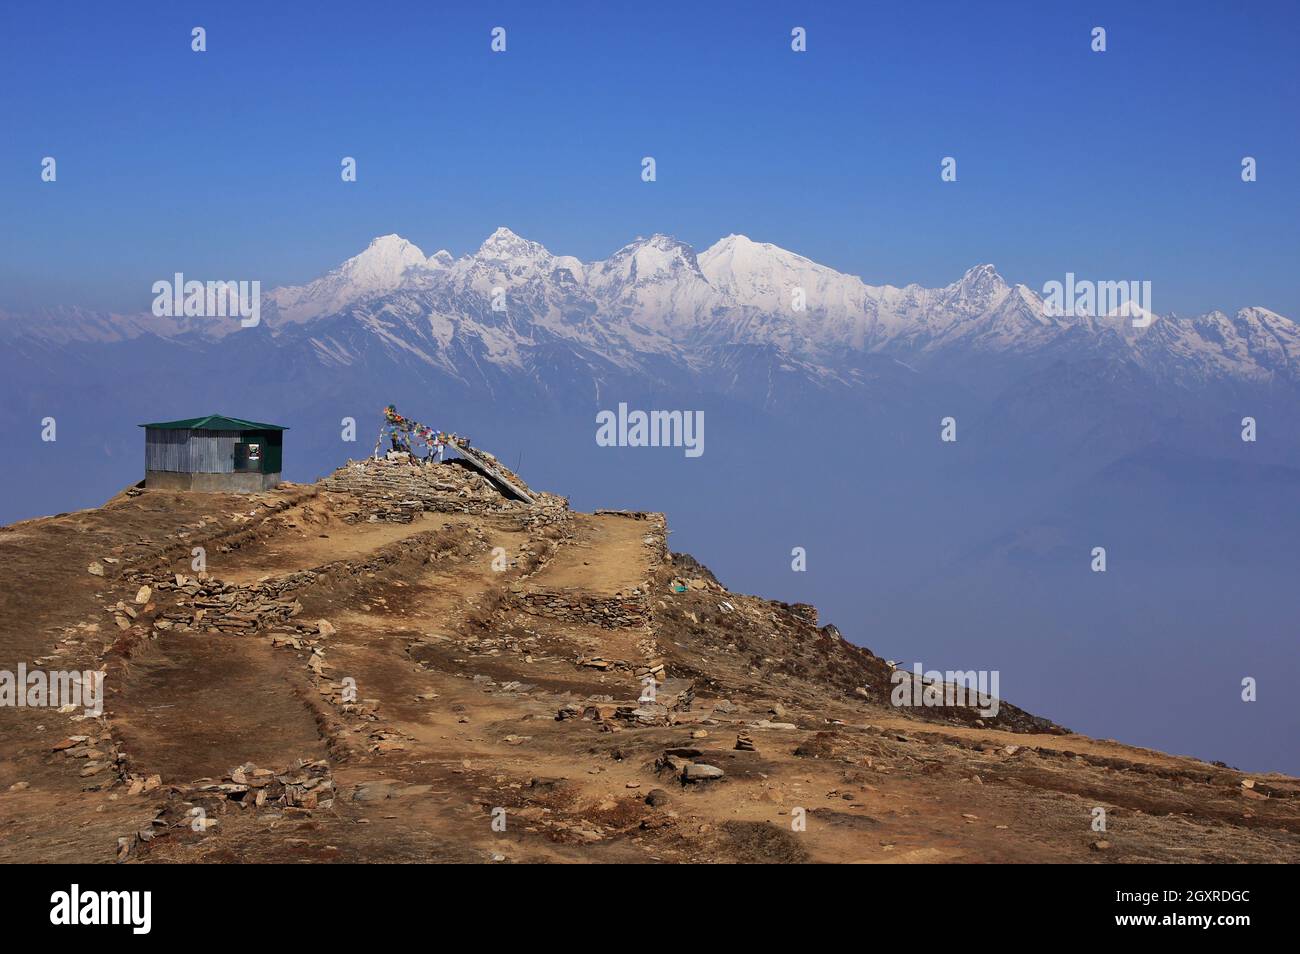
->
[140,415,287,494]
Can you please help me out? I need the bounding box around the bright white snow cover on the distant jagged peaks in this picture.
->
[244,226,1300,380]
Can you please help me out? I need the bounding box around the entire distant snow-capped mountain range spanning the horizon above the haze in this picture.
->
[0,227,1300,395]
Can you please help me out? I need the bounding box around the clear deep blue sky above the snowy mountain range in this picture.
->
[0,1,1300,318]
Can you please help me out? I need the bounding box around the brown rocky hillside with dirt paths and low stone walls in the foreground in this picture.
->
[0,460,1300,863]
